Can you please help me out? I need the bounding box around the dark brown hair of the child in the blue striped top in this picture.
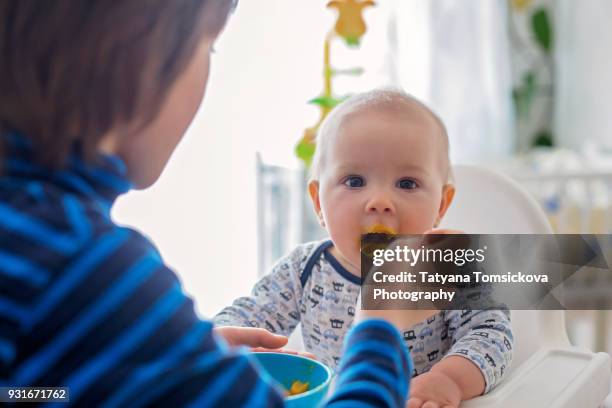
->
[0,0,236,167]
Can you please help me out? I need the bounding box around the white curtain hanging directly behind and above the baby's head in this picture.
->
[394,0,515,162]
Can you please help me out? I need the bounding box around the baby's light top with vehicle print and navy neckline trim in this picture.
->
[214,240,513,392]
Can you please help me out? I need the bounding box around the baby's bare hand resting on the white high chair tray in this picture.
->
[406,371,461,408]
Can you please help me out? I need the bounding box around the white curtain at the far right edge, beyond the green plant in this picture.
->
[555,0,612,153]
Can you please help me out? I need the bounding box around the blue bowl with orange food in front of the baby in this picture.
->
[253,353,332,408]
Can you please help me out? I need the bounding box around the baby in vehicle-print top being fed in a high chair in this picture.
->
[215,90,513,407]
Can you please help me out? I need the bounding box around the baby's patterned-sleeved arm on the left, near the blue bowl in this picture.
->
[213,247,304,336]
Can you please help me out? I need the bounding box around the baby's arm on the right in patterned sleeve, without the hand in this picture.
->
[442,310,513,398]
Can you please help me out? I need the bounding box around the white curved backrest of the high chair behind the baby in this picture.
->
[441,165,569,370]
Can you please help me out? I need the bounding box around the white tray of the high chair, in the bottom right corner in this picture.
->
[461,348,611,408]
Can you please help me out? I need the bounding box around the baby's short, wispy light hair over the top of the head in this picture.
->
[310,88,452,182]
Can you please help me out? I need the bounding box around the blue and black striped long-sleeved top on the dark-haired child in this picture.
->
[0,134,412,407]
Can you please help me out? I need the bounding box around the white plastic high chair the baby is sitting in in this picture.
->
[441,165,611,408]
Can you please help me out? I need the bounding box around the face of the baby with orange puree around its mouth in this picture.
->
[315,108,452,270]
